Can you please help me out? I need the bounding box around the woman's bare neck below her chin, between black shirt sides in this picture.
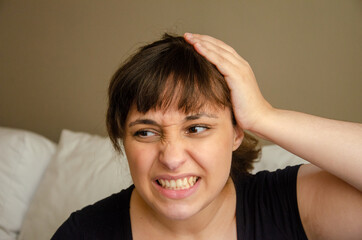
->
[131,178,236,239]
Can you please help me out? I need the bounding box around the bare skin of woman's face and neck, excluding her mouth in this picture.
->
[123,107,243,239]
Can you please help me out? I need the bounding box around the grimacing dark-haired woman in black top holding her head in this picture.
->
[53,33,362,239]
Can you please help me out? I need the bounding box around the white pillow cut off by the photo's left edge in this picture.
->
[0,127,56,240]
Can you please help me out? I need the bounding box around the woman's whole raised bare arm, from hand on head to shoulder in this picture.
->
[184,33,362,239]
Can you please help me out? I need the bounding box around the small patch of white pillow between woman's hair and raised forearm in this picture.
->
[252,145,308,173]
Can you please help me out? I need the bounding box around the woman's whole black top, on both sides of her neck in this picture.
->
[52,166,307,240]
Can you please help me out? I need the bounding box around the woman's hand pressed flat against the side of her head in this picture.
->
[184,33,273,131]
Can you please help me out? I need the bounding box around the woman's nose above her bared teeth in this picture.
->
[159,141,186,171]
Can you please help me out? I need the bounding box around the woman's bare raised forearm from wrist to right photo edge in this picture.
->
[249,109,362,191]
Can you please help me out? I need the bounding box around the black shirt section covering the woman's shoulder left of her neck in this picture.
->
[52,186,134,239]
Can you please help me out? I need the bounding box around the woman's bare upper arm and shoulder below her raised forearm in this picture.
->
[297,164,362,239]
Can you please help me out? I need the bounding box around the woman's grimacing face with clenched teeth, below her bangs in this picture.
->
[123,104,243,220]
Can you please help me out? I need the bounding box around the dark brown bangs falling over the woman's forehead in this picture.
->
[134,36,231,113]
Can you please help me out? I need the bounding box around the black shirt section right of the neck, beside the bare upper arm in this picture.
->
[241,165,307,239]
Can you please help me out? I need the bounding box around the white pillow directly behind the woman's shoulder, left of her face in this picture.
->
[19,130,132,240]
